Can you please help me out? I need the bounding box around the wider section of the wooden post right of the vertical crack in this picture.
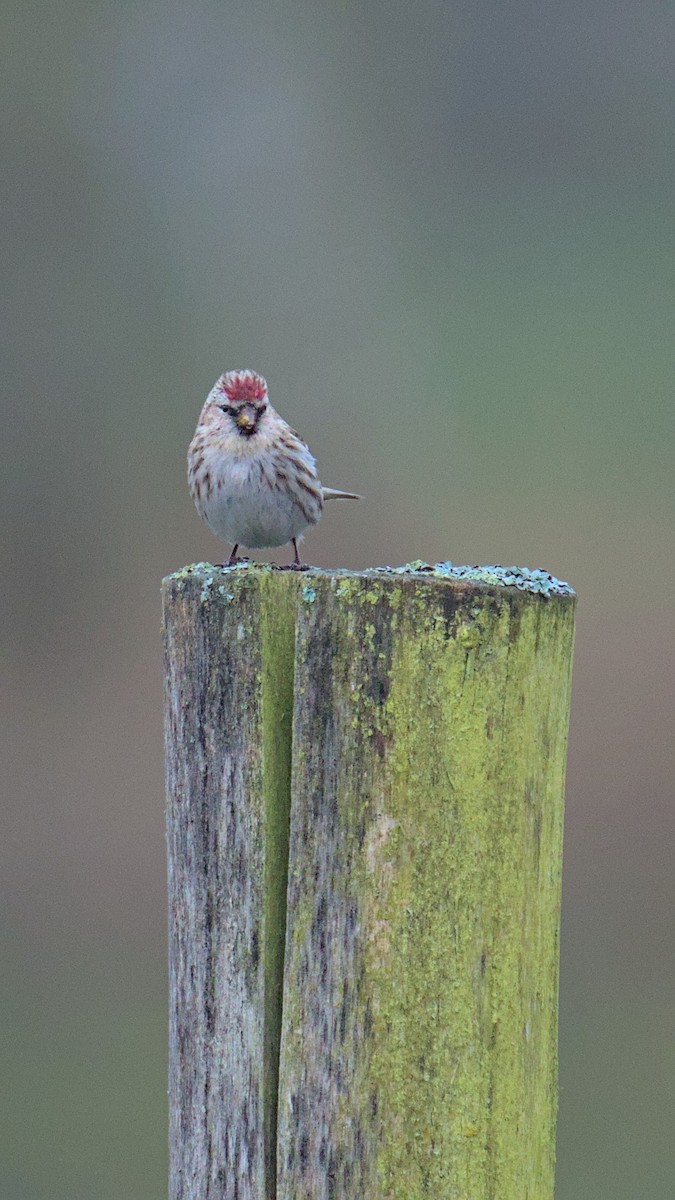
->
[277,574,574,1200]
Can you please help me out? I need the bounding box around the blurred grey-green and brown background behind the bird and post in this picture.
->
[0,0,675,1200]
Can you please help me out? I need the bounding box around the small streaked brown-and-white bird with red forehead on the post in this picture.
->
[187,371,360,568]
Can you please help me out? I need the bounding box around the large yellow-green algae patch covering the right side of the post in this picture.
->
[355,585,572,1200]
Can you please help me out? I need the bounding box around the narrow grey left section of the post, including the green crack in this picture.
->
[163,570,295,1200]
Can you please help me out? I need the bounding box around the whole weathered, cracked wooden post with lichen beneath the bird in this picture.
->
[163,563,574,1200]
